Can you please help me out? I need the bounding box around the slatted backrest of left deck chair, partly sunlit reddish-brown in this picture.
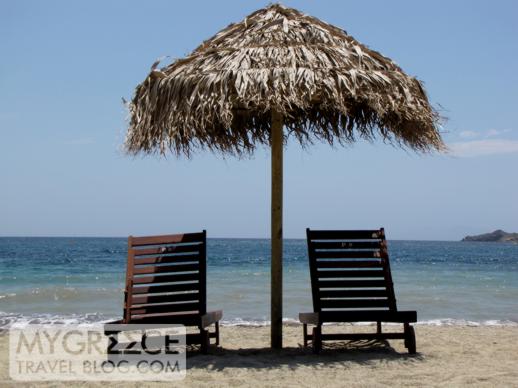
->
[123,230,207,323]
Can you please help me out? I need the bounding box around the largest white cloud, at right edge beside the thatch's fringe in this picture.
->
[448,139,518,158]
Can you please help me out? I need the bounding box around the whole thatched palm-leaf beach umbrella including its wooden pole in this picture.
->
[126,4,444,348]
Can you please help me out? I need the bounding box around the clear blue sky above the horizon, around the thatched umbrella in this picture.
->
[0,0,518,240]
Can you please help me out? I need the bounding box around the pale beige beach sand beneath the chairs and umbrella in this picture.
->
[0,325,518,388]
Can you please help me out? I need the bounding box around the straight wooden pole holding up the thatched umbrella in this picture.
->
[271,111,283,349]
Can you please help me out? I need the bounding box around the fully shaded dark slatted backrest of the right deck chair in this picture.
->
[306,228,397,312]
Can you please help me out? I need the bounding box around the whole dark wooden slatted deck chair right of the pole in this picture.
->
[299,228,417,354]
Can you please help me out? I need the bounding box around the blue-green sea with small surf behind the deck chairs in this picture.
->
[0,237,518,329]
